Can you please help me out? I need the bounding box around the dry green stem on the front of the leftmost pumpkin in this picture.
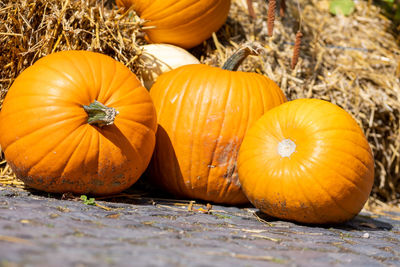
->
[83,100,119,127]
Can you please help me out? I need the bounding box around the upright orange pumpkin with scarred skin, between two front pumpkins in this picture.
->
[148,47,286,204]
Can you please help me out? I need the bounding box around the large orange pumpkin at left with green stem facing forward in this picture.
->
[0,51,157,195]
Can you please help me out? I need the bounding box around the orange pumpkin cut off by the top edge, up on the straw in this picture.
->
[116,0,231,49]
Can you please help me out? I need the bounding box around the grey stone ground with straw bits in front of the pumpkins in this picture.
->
[0,187,400,267]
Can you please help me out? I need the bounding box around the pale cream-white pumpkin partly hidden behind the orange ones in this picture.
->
[140,44,200,89]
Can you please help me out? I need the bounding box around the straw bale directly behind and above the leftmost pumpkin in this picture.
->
[0,0,142,103]
